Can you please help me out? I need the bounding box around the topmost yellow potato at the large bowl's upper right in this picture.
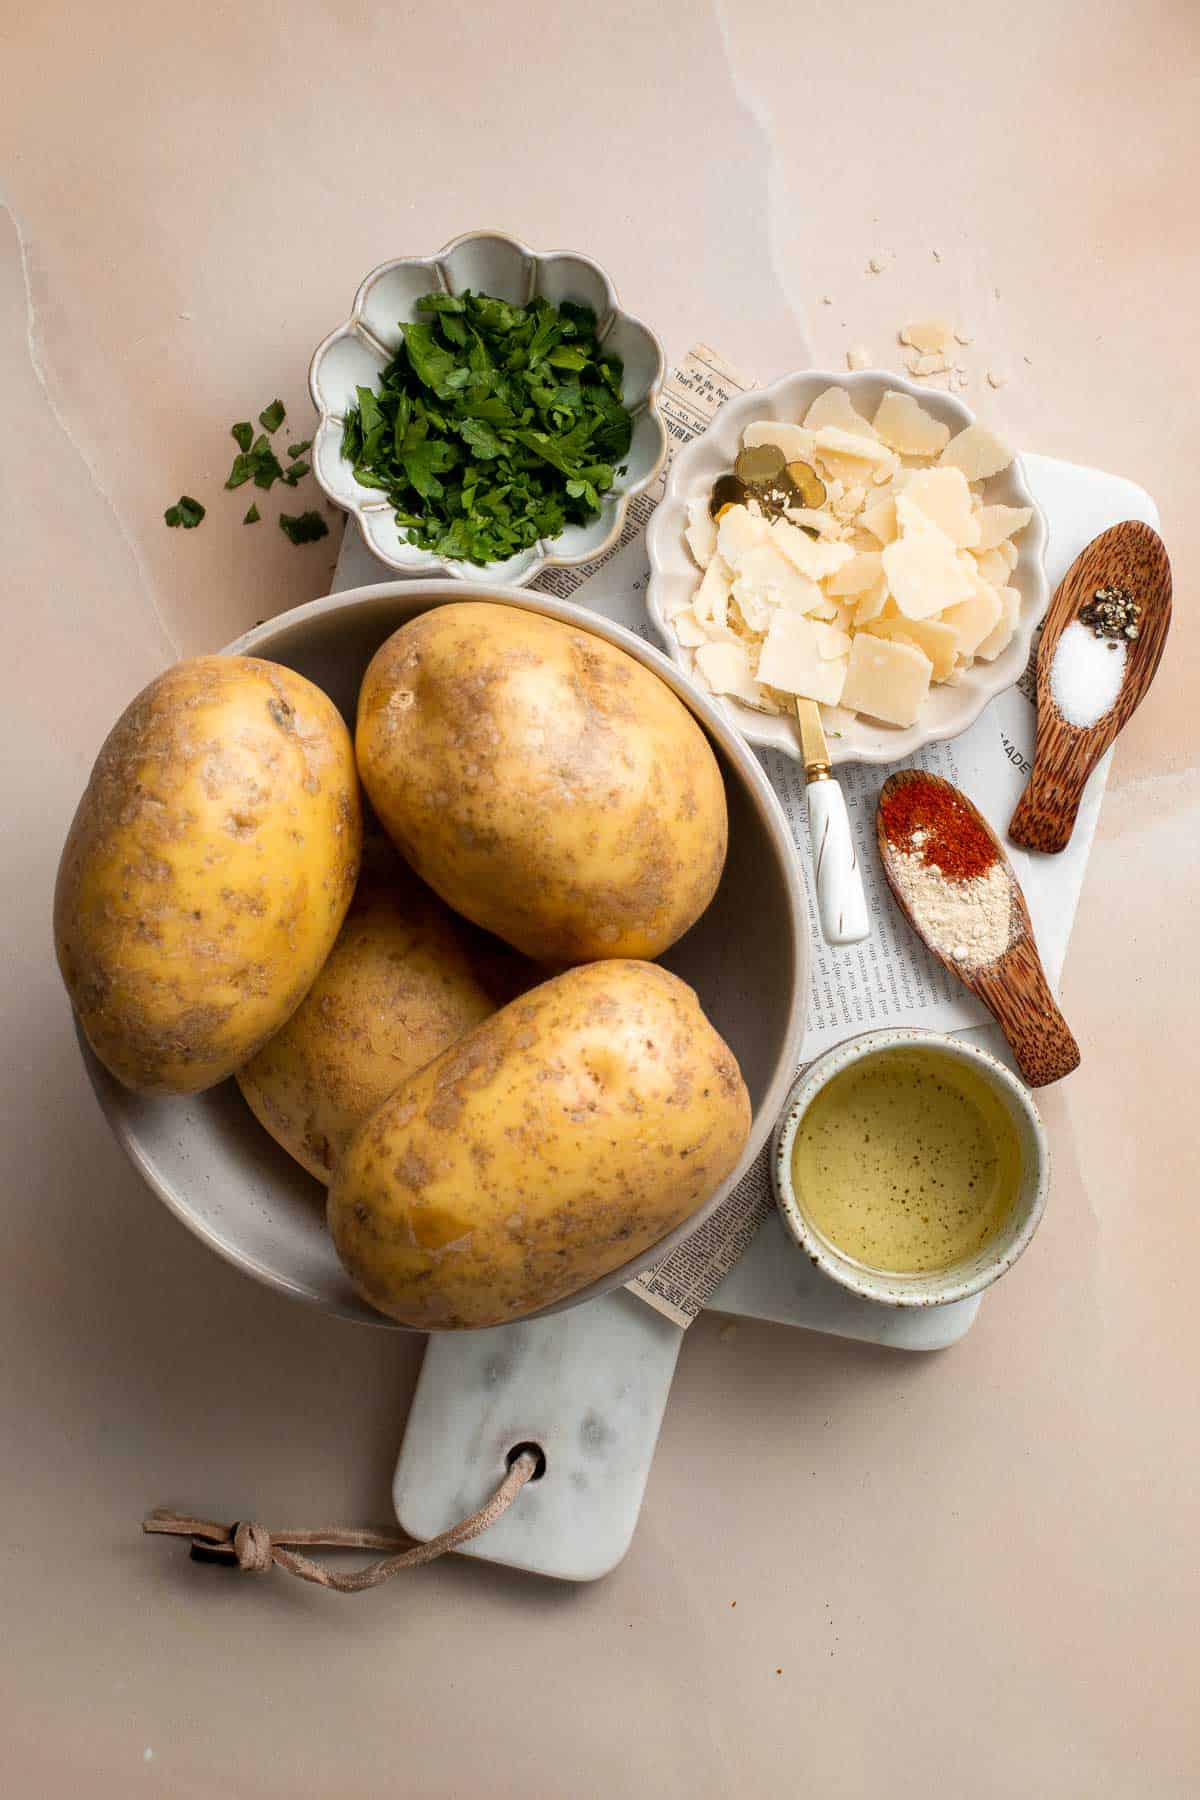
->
[356,601,727,963]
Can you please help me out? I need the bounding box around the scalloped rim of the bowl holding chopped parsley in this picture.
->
[308,230,667,587]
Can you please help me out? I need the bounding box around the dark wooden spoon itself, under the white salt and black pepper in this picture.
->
[1007,518,1171,853]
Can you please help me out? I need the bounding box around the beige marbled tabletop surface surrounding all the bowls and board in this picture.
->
[0,0,1200,1800]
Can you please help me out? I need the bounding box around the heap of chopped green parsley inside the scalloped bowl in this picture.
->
[340,292,633,565]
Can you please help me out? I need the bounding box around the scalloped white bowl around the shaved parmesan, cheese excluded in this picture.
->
[646,369,1051,763]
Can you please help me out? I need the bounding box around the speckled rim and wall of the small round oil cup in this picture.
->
[770,1030,1051,1307]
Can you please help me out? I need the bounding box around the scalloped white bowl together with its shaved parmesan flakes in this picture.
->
[649,365,1049,761]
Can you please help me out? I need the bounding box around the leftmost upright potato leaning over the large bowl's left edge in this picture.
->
[54,657,362,1094]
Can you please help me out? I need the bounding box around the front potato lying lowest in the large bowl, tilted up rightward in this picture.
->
[327,961,750,1330]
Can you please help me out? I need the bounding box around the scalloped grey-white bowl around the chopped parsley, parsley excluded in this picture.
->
[308,230,667,585]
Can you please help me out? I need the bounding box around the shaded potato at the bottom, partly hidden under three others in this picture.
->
[237,839,540,1183]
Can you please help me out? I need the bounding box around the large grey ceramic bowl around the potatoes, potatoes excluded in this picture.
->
[79,581,808,1327]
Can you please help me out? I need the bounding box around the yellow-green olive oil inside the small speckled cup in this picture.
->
[792,1048,1022,1274]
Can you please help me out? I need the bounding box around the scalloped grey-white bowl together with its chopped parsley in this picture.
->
[311,234,666,581]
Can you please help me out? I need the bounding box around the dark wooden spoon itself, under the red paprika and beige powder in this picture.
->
[874,769,1079,1087]
